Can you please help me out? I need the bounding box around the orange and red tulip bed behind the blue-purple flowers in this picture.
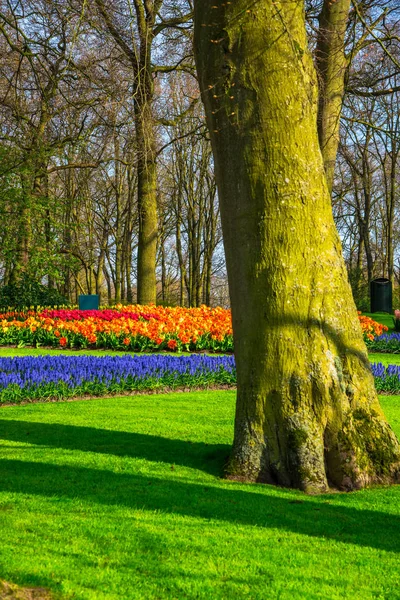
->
[0,305,390,352]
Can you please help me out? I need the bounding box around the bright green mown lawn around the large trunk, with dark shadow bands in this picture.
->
[0,391,400,600]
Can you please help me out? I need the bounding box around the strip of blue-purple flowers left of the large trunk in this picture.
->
[0,355,236,403]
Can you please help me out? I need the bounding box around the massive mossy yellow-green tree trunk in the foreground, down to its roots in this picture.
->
[195,0,400,492]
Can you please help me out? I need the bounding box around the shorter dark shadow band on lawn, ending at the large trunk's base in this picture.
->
[0,419,230,476]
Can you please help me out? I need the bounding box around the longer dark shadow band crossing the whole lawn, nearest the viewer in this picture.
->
[0,460,400,552]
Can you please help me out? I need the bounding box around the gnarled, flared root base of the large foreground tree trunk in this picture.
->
[226,409,400,494]
